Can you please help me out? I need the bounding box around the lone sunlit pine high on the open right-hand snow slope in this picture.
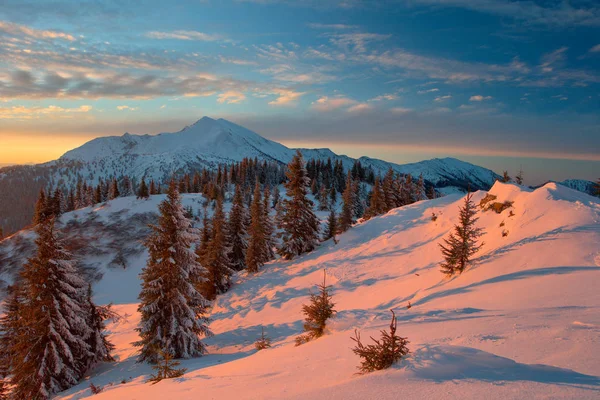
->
[440,193,483,276]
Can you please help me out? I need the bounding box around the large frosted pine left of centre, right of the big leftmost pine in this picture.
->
[135,181,211,362]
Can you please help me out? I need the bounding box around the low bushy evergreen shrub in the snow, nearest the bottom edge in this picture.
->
[351,310,409,374]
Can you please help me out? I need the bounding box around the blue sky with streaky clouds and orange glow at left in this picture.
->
[0,0,600,184]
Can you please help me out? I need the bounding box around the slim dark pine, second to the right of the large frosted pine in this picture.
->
[227,185,248,271]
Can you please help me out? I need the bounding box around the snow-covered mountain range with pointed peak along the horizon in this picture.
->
[0,117,498,233]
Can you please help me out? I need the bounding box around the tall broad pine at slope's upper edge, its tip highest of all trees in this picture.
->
[279,151,319,260]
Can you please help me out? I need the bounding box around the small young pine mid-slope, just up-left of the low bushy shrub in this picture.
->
[296,270,336,346]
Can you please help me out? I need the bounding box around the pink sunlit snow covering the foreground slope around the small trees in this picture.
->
[48,182,600,400]
